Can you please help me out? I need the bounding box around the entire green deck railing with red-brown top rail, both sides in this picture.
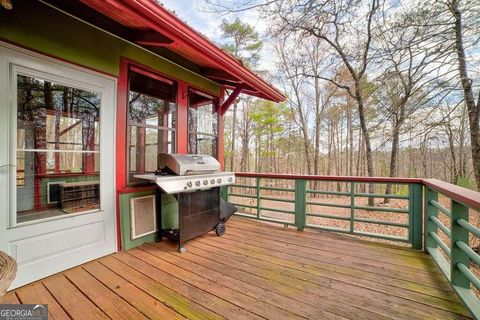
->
[223,173,480,319]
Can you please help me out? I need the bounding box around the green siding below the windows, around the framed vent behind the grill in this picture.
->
[119,190,178,250]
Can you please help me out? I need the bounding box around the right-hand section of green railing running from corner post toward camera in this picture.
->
[424,179,480,319]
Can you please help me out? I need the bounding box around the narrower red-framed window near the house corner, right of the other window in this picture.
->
[188,90,218,158]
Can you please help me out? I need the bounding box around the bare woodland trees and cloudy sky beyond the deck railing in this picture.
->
[206,0,480,193]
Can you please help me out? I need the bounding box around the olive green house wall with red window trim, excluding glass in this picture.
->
[0,0,223,249]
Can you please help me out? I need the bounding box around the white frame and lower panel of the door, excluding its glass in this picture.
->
[0,42,117,289]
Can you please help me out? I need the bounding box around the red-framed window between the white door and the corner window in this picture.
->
[127,67,177,185]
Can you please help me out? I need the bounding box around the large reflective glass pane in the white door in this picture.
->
[17,75,101,223]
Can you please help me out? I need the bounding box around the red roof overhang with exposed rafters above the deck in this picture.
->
[46,0,285,102]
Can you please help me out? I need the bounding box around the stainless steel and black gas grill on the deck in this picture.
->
[135,154,237,252]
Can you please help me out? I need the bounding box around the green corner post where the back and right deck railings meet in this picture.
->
[408,184,423,250]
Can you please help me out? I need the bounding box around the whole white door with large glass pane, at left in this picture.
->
[0,42,116,289]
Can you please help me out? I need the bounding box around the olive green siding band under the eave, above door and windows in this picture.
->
[0,0,220,93]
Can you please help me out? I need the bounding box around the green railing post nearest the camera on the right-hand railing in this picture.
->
[450,200,470,289]
